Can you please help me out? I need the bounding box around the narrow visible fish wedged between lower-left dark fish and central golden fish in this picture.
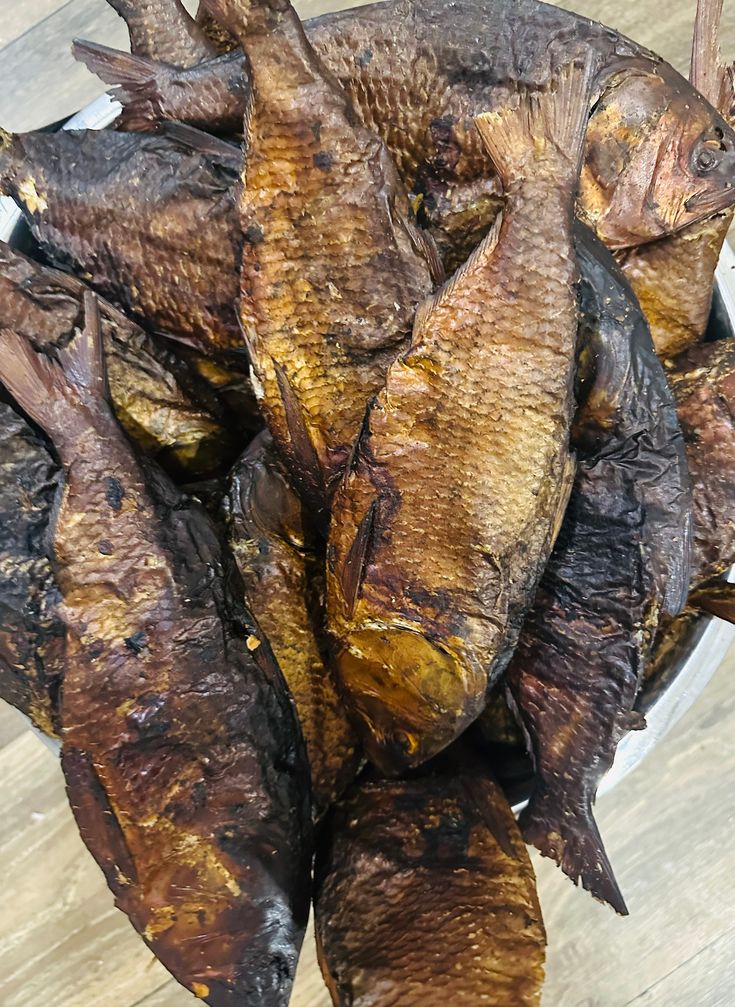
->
[226,432,359,818]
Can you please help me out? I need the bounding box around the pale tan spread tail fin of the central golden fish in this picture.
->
[474,52,598,188]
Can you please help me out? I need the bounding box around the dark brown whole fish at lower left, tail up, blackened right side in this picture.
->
[0,295,311,1007]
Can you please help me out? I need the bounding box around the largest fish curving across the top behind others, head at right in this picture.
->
[83,0,735,269]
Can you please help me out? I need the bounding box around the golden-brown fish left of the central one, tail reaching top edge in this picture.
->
[200,0,433,509]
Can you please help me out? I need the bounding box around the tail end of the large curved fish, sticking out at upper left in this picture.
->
[71,39,250,135]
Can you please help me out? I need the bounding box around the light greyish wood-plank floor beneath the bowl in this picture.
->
[0,0,735,1007]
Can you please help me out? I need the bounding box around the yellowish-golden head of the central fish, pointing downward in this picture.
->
[336,624,487,775]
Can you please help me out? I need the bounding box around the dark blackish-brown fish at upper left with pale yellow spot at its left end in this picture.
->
[0,127,242,353]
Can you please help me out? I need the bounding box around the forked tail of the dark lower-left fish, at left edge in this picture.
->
[0,291,108,443]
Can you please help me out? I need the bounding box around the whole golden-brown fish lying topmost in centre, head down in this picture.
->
[327,61,593,771]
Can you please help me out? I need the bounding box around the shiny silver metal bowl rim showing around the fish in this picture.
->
[0,95,735,785]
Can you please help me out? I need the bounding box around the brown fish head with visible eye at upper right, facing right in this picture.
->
[578,63,735,248]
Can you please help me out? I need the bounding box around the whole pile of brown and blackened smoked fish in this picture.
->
[0,0,735,1007]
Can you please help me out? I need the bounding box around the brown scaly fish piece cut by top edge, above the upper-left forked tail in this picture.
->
[107,0,216,66]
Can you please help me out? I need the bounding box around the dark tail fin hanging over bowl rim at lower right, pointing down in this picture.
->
[520,781,628,916]
